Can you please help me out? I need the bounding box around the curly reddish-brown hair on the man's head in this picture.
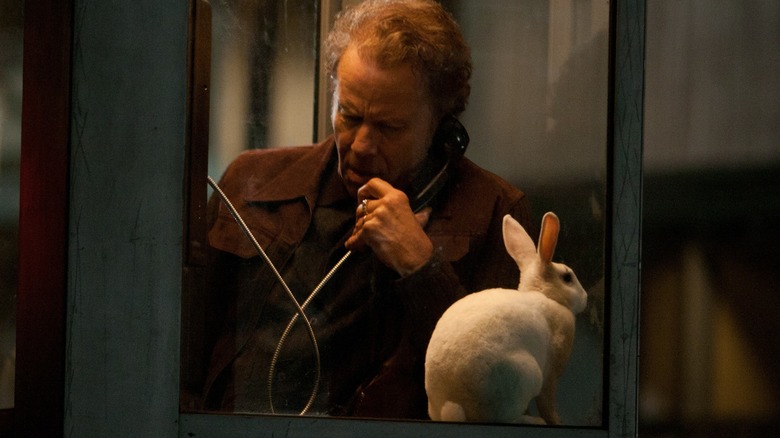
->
[324,0,471,115]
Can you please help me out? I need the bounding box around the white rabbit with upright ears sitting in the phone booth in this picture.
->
[425,212,587,424]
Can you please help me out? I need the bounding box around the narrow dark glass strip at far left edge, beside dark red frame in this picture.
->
[0,1,24,409]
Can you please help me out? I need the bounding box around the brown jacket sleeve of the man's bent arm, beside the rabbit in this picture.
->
[351,192,530,419]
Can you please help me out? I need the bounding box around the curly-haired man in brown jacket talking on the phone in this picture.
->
[198,0,530,418]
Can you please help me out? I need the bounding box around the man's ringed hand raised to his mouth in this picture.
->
[345,178,433,277]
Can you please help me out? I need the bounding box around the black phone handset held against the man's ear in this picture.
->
[407,116,469,213]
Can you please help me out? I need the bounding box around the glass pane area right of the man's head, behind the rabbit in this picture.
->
[445,0,609,425]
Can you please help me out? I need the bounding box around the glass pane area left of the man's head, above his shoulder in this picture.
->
[209,0,319,177]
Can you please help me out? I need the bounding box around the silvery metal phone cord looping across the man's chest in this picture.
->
[206,176,330,415]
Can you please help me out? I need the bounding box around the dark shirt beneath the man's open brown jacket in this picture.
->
[232,158,381,414]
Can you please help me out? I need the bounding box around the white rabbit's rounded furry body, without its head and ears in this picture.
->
[425,289,550,421]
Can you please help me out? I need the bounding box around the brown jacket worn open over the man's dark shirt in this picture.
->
[198,137,533,418]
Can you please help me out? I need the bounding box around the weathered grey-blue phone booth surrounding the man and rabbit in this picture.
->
[14,0,644,437]
